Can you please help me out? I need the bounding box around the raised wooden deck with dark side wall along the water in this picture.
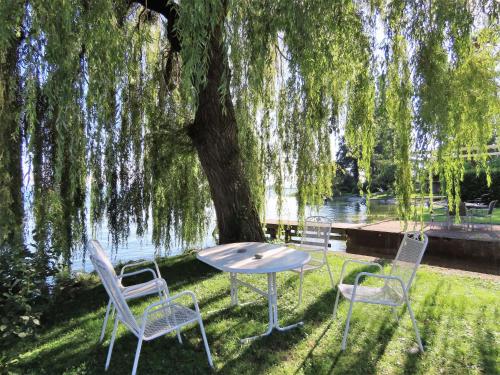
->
[266,219,500,275]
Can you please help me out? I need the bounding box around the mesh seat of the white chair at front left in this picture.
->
[138,303,198,340]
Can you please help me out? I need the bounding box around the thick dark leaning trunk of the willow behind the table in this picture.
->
[188,27,265,243]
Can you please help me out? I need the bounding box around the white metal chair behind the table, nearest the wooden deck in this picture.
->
[292,216,335,306]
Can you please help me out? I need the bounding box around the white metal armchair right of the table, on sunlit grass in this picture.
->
[333,232,429,352]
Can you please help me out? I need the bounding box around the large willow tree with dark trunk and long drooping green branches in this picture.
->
[0,0,499,274]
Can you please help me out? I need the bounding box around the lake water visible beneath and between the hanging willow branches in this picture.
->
[73,189,396,272]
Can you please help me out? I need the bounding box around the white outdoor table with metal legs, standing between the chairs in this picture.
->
[197,242,311,342]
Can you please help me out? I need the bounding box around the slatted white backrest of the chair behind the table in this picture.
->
[300,216,332,264]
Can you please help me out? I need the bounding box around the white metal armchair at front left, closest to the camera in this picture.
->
[88,240,213,375]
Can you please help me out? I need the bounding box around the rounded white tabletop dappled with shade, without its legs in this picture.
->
[197,242,311,273]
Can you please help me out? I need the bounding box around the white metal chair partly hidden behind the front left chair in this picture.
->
[89,241,169,342]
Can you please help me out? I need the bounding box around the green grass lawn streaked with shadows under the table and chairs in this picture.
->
[0,254,500,375]
